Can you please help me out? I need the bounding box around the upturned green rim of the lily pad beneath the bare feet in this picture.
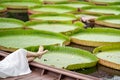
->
[27,46,98,70]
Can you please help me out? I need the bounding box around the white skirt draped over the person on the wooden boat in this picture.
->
[0,49,31,78]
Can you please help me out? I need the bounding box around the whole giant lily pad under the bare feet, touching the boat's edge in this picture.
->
[27,46,98,70]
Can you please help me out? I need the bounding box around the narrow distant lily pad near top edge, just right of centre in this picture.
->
[57,1,93,8]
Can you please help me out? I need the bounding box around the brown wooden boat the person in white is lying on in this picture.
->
[0,51,102,80]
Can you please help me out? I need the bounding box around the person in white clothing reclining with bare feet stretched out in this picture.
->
[0,46,47,78]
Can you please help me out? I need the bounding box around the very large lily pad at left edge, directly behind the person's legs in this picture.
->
[0,29,69,48]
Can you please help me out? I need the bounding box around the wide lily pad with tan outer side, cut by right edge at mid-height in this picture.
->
[71,28,120,46]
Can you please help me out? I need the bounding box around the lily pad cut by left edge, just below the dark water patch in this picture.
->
[0,18,24,29]
